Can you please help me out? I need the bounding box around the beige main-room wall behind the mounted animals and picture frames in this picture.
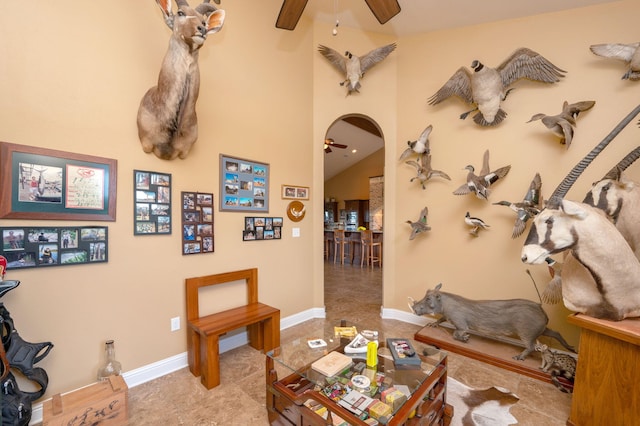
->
[0,0,640,396]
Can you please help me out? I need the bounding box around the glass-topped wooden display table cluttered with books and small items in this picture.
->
[266,324,453,426]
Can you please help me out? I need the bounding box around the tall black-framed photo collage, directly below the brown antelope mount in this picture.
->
[133,170,171,235]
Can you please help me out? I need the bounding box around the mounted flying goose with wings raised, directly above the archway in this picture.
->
[318,43,396,96]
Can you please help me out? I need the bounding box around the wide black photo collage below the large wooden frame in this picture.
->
[0,226,108,269]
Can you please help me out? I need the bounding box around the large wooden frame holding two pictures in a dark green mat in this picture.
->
[0,142,118,221]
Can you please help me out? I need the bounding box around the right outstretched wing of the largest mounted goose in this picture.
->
[496,47,566,88]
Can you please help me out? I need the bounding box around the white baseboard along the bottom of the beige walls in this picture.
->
[29,307,420,425]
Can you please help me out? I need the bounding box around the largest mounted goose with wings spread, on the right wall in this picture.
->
[429,47,566,126]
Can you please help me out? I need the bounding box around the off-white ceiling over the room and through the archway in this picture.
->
[318,0,616,180]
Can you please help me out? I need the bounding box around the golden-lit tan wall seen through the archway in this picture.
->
[324,148,384,210]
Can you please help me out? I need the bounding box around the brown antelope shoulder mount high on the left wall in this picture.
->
[138,0,225,160]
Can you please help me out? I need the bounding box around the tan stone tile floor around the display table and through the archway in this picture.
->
[124,261,571,426]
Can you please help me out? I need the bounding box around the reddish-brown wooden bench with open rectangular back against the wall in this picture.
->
[185,268,280,389]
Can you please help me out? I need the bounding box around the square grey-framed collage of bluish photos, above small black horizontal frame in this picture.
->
[220,154,269,212]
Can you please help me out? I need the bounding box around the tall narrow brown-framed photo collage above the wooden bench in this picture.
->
[182,192,214,254]
